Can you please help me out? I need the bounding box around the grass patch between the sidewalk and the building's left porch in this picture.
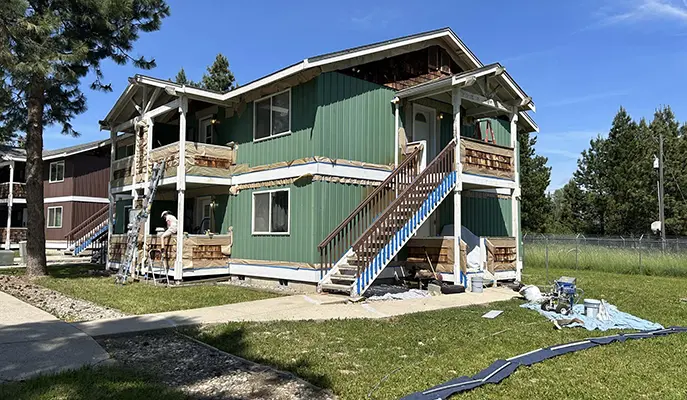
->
[0,264,278,314]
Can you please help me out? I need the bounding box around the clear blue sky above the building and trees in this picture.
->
[45,0,687,190]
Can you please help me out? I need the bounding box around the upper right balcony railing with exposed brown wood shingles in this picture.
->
[460,138,515,179]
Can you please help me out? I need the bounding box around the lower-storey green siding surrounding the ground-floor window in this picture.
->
[230,183,317,263]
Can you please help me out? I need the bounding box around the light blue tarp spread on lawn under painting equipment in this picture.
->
[520,303,663,331]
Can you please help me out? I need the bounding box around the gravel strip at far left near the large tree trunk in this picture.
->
[0,275,126,321]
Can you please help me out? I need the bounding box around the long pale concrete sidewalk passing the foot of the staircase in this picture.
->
[72,288,517,337]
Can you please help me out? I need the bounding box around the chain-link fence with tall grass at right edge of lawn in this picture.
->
[523,234,687,276]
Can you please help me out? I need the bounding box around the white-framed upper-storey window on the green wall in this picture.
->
[253,89,291,140]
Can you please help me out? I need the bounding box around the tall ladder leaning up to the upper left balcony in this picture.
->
[115,160,165,285]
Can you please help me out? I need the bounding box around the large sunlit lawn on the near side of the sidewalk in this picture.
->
[191,268,687,400]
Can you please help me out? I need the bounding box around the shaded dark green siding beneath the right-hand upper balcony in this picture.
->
[461,196,513,236]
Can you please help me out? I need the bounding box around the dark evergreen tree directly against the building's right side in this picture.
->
[518,133,551,232]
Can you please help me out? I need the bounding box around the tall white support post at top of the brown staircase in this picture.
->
[451,86,463,285]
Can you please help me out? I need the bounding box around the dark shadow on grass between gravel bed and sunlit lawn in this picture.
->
[181,326,332,390]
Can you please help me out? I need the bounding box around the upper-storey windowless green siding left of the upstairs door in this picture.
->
[316,72,395,164]
